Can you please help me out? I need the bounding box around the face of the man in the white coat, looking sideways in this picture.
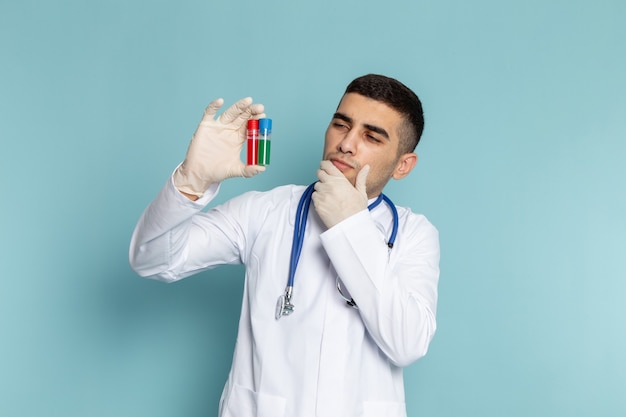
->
[324,93,417,198]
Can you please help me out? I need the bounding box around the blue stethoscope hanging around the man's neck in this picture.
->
[276,183,398,320]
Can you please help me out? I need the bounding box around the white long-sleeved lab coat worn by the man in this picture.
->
[130,176,439,417]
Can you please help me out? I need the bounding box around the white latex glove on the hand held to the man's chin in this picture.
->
[311,161,370,229]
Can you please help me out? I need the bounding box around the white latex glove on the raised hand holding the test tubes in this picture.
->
[174,97,265,197]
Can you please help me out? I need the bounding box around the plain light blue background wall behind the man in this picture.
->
[0,0,626,417]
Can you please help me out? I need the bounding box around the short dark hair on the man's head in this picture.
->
[344,74,424,155]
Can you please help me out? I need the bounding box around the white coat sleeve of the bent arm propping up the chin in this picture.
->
[321,210,440,366]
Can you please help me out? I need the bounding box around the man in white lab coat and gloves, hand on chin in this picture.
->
[130,74,439,417]
